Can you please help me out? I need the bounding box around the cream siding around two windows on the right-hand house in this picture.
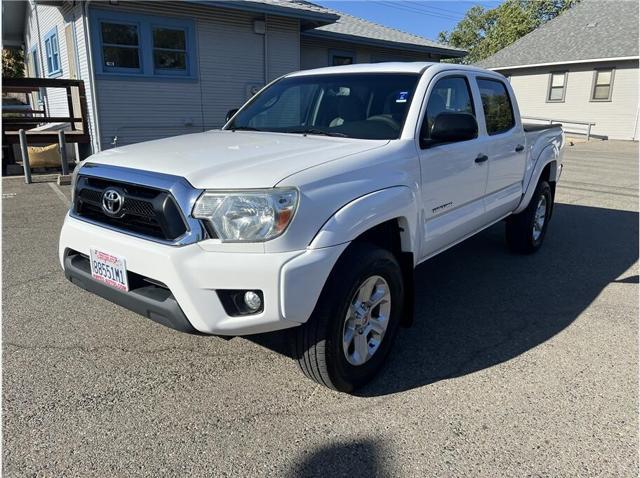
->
[501,60,638,140]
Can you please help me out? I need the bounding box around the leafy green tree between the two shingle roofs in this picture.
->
[438,0,579,63]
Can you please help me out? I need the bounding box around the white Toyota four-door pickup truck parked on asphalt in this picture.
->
[59,63,564,392]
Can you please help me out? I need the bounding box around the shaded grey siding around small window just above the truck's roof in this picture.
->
[300,36,438,70]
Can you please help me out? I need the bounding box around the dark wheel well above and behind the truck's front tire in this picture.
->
[352,218,415,327]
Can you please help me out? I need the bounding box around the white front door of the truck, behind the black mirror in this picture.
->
[419,73,488,259]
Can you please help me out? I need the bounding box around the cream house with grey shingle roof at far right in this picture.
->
[479,0,640,140]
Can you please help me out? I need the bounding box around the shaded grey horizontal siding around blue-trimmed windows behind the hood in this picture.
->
[87,2,300,149]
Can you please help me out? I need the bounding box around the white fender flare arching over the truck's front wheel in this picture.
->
[309,186,419,252]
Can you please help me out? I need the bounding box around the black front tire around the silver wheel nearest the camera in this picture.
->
[294,243,404,392]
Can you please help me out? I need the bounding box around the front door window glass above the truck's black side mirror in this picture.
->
[420,76,475,141]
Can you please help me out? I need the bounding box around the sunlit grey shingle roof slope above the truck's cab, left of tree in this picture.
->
[305,10,467,57]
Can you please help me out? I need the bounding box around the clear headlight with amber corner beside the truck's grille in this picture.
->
[193,188,298,242]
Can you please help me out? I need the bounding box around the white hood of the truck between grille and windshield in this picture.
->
[88,130,389,189]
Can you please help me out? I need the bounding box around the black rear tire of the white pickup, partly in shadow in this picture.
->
[506,181,553,254]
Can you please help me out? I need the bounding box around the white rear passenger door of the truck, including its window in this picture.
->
[475,75,526,222]
